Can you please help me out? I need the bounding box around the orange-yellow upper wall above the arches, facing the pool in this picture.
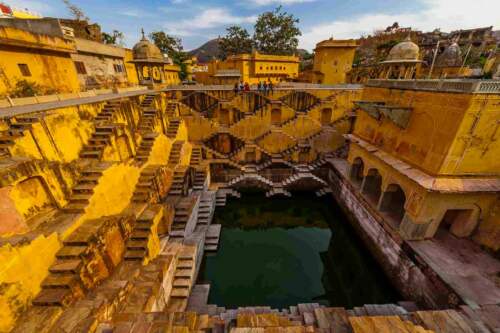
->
[354,87,472,175]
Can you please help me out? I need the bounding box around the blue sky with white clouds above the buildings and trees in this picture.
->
[4,0,500,50]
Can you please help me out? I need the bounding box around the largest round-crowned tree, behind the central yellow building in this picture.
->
[253,6,302,55]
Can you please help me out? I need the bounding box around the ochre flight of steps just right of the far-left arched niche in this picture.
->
[62,163,110,214]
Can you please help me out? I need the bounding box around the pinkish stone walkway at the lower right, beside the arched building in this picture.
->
[407,231,500,307]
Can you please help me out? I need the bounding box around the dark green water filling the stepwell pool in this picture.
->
[199,193,400,308]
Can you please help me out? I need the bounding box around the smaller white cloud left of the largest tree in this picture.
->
[164,8,256,36]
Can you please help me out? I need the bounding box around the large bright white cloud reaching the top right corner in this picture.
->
[300,0,500,50]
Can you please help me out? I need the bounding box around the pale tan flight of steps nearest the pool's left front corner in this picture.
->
[167,247,196,312]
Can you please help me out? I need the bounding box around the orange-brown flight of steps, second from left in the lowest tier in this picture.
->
[124,210,156,261]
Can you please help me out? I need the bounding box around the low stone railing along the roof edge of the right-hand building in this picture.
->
[366,79,500,94]
